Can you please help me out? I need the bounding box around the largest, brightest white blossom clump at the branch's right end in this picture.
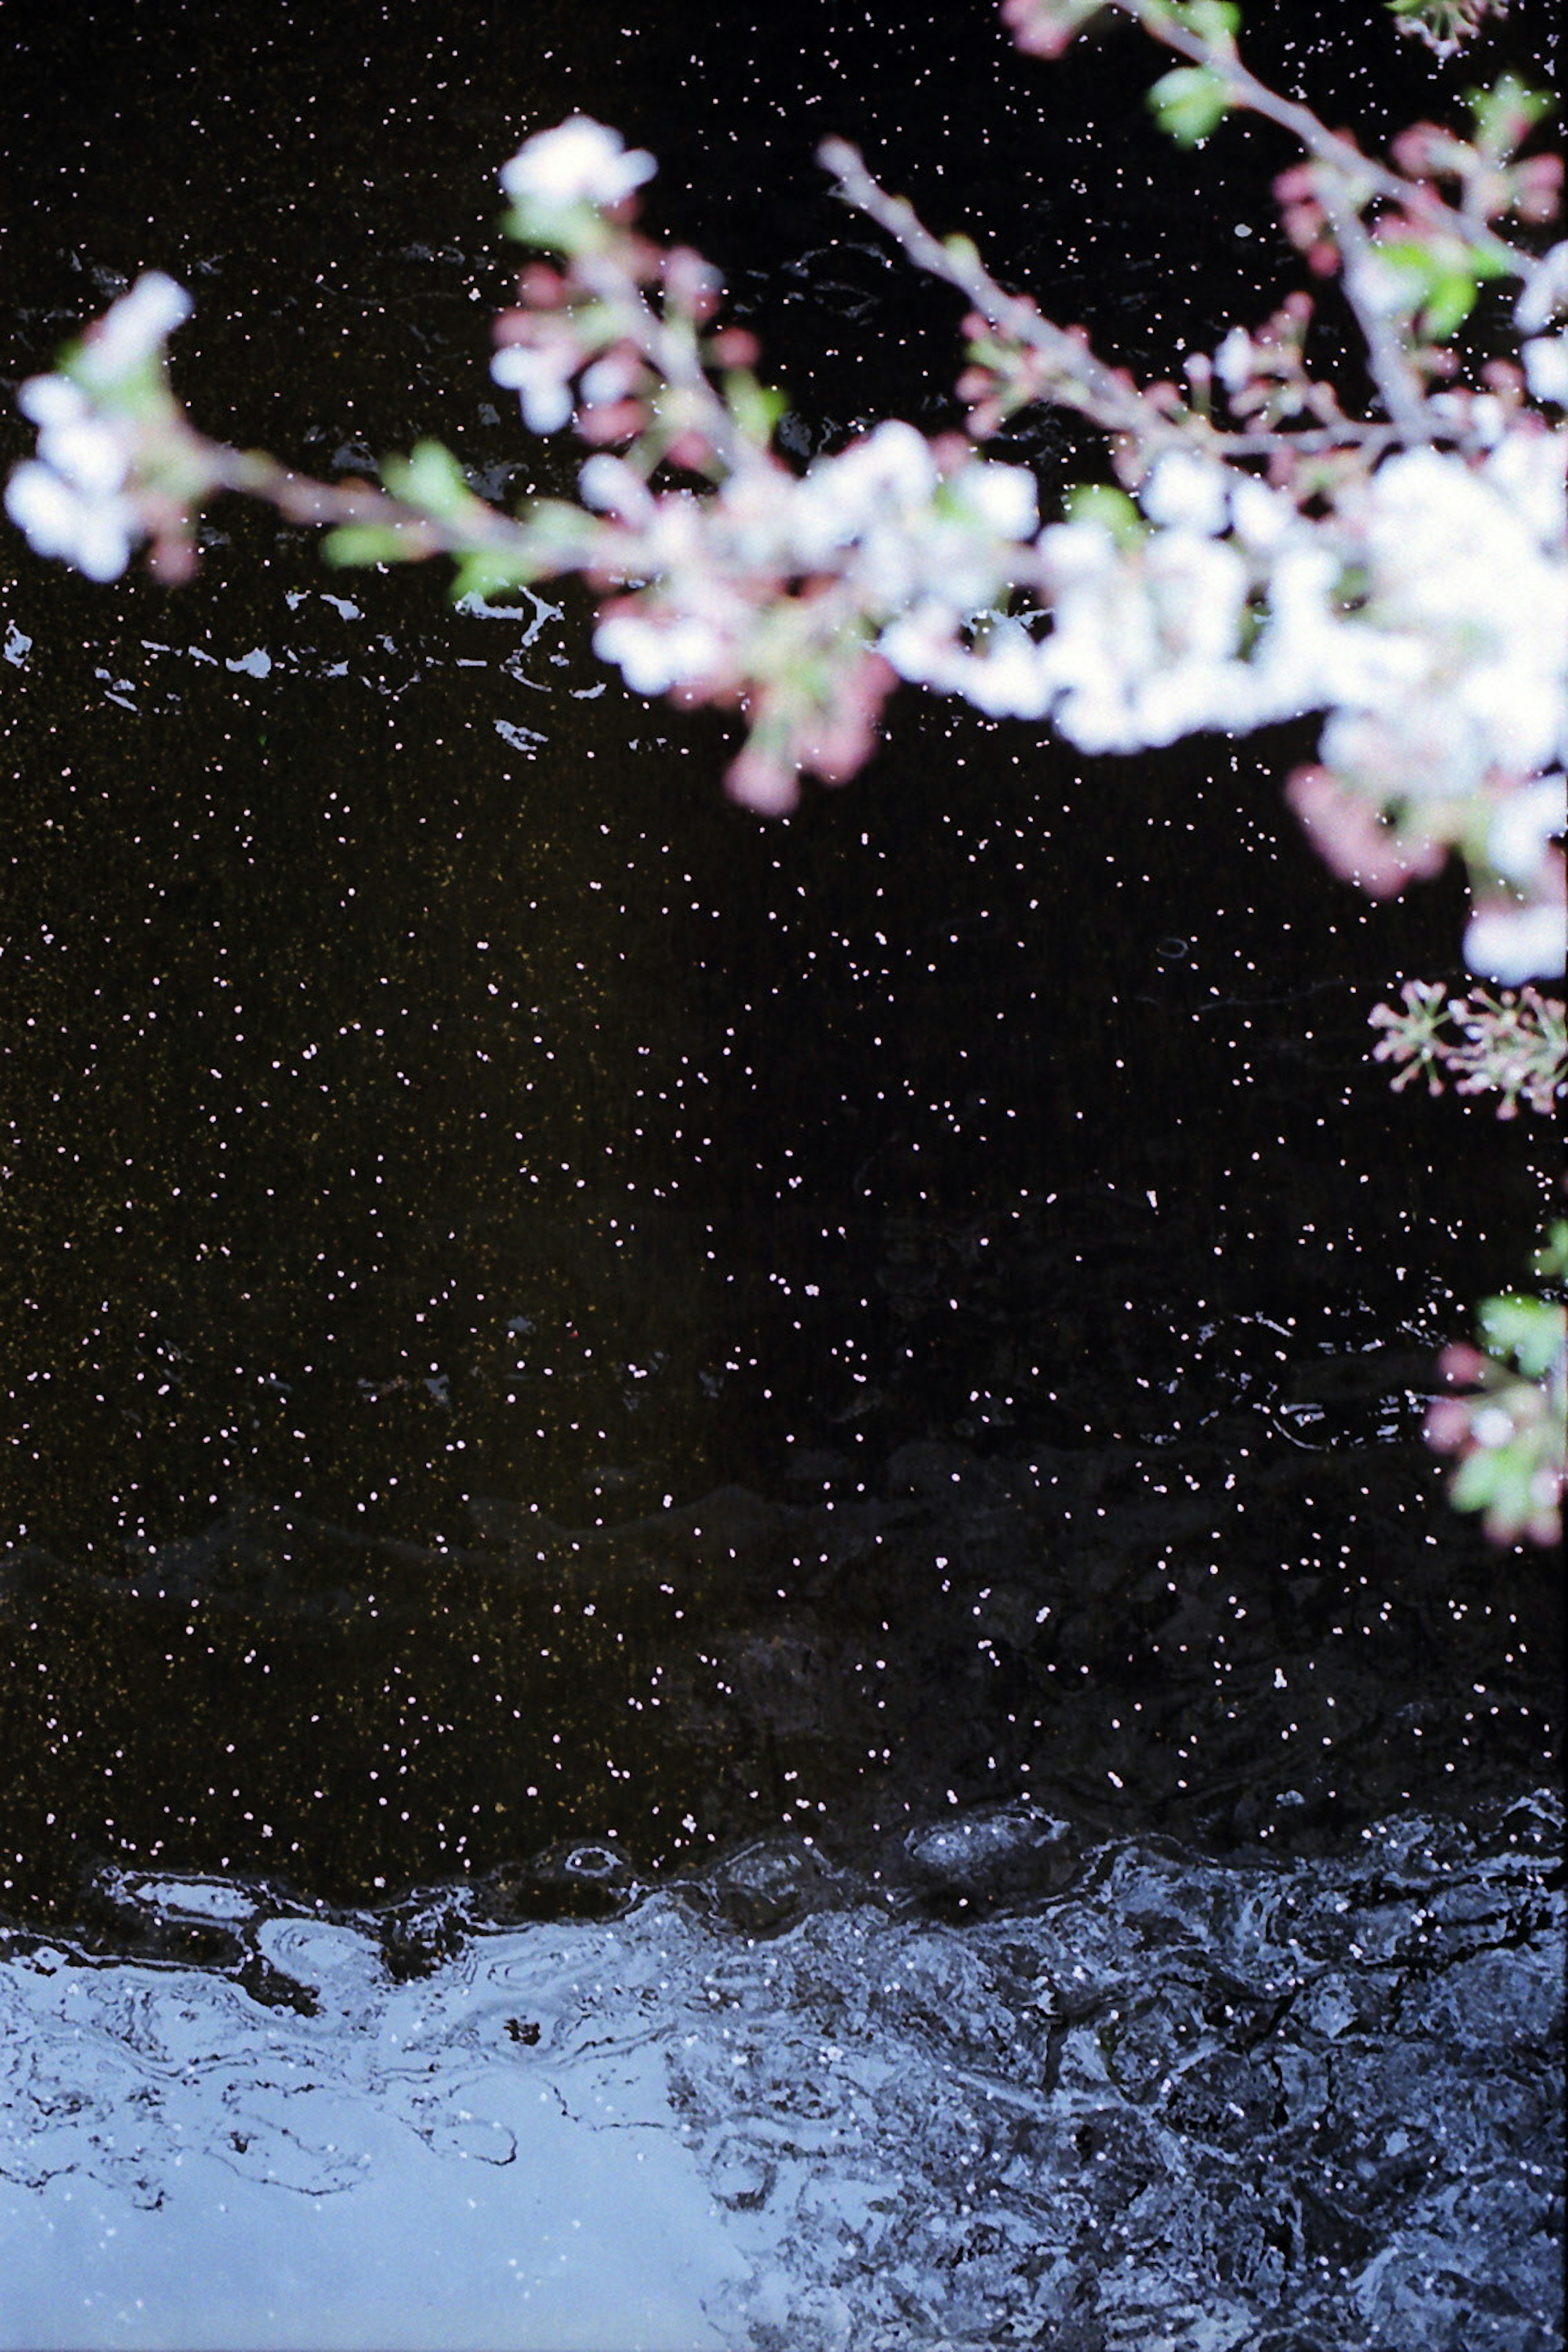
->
[1258,428,1568,945]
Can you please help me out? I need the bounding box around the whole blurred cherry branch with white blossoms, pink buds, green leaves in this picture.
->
[7,23,1568,1526]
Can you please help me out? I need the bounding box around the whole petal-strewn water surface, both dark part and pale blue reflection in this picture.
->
[0,0,1561,2352]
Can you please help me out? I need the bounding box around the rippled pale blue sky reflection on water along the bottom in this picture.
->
[0,1797,1563,2352]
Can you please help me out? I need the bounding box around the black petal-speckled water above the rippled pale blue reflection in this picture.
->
[0,0,1556,1910]
